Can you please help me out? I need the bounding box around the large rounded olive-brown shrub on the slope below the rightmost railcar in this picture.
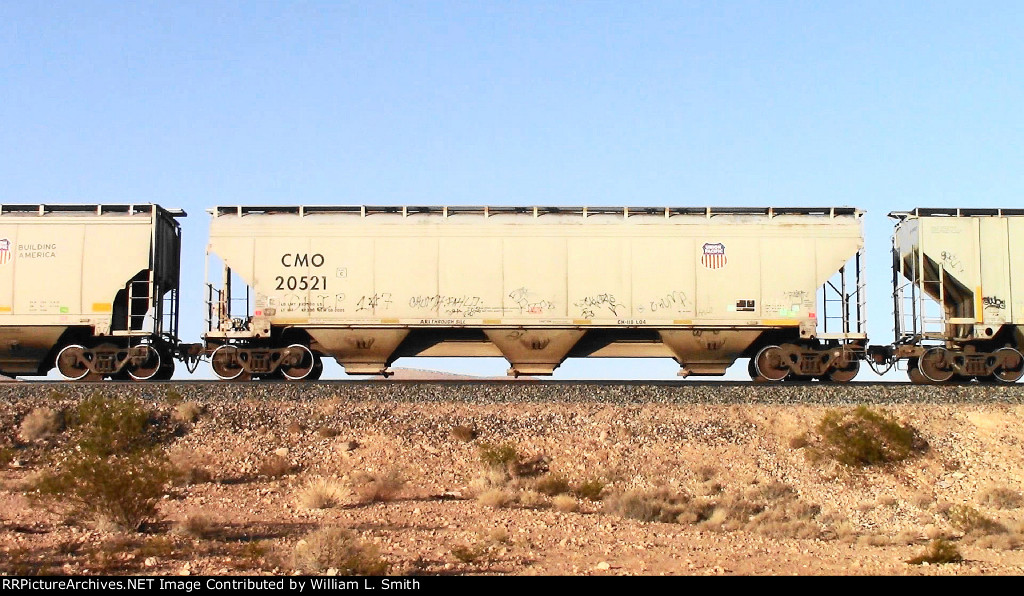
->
[806,406,928,467]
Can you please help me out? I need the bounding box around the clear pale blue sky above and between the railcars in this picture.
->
[0,0,1024,379]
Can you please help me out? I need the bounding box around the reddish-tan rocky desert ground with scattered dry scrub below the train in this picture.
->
[0,383,1024,576]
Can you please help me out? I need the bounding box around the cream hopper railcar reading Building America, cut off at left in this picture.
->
[0,205,193,380]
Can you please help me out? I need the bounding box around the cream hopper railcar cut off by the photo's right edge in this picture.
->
[871,208,1024,383]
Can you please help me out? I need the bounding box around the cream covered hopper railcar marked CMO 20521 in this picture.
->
[204,206,867,381]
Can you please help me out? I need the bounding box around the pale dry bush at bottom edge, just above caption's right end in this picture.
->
[292,527,390,576]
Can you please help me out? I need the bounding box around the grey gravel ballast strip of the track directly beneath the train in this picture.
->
[0,379,1024,406]
